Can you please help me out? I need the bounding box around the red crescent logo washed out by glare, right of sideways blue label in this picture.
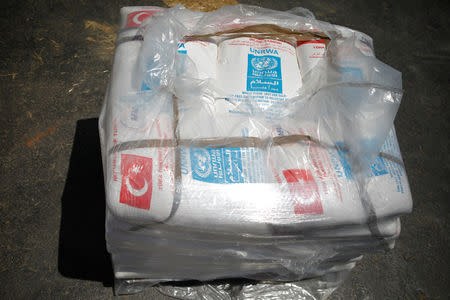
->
[283,169,323,215]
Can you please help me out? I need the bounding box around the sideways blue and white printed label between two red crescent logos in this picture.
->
[187,148,263,184]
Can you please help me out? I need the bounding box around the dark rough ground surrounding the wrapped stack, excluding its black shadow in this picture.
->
[0,0,450,299]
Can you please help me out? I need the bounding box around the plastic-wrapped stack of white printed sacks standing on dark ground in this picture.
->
[99,5,412,299]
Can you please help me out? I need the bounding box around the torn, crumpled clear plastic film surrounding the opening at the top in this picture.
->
[135,5,403,176]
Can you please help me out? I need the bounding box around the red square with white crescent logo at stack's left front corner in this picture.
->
[120,154,152,210]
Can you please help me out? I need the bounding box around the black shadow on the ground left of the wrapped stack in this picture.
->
[58,119,113,286]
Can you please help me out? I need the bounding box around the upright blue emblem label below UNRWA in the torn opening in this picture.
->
[247,54,283,93]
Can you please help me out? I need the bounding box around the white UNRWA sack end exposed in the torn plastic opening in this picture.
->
[217,37,302,118]
